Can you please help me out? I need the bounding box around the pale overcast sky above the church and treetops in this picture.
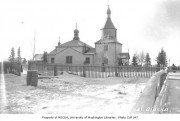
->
[0,0,180,65]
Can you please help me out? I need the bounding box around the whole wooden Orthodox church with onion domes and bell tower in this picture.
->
[48,6,130,65]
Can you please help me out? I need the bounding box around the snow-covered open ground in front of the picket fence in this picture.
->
[0,72,149,115]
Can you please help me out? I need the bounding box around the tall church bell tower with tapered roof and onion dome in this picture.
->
[95,5,122,65]
